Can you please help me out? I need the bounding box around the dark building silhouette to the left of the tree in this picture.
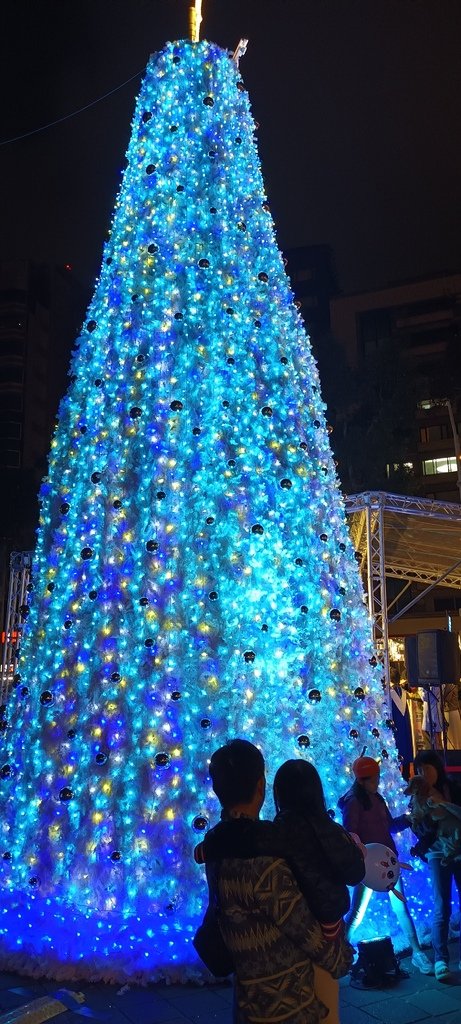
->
[0,260,86,627]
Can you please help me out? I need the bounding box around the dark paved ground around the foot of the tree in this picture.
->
[0,944,461,1024]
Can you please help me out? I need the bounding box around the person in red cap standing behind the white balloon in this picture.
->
[338,757,433,974]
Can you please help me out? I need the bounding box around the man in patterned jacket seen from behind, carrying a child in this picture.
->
[196,739,352,1024]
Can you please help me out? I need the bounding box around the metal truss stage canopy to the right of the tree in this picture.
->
[345,490,461,684]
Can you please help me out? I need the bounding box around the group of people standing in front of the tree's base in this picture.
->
[195,739,461,1024]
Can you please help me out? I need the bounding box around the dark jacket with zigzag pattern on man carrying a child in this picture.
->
[197,818,352,1024]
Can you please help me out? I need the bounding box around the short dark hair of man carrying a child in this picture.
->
[210,739,265,810]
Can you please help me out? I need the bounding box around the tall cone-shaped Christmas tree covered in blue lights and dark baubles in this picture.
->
[0,32,424,979]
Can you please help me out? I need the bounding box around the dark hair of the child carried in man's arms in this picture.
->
[274,760,327,816]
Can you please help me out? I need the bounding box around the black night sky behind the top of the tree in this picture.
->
[0,0,461,292]
